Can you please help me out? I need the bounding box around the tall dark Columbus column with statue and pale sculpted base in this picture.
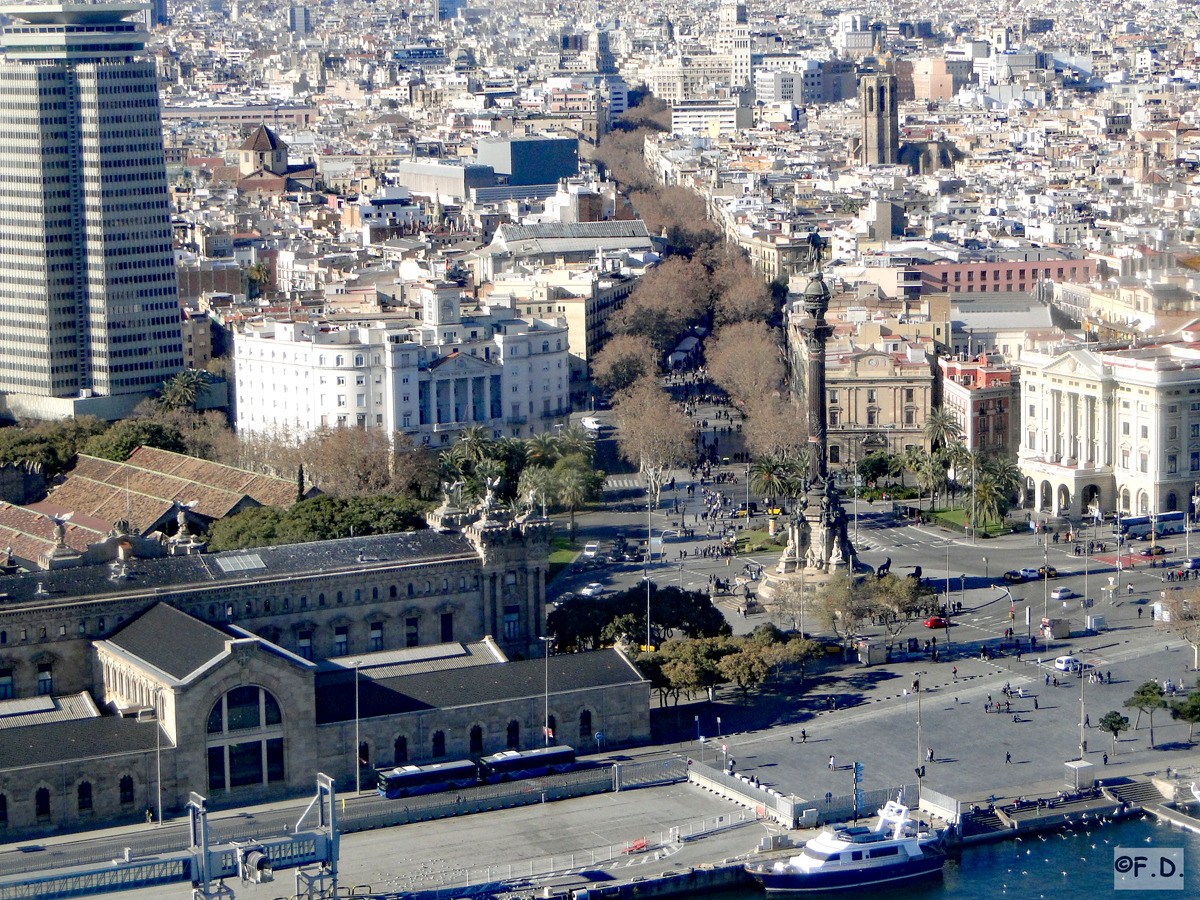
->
[758,233,854,601]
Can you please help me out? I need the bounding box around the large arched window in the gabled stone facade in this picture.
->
[206,685,284,791]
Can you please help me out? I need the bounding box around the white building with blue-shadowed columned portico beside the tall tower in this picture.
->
[234,283,571,446]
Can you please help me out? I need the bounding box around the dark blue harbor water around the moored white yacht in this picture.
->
[713,815,1200,900]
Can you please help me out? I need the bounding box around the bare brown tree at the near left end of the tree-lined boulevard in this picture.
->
[617,378,696,508]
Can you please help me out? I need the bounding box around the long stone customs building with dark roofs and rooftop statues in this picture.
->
[0,506,649,840]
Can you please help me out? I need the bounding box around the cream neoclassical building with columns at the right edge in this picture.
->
[1018,341,1200,522]
